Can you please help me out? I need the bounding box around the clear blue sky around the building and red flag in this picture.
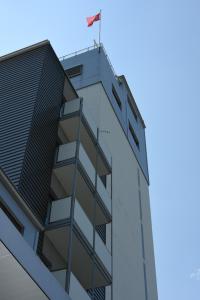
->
[0,0,200,300]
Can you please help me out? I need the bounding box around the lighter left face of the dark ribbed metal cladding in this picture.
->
[0,49,46,187]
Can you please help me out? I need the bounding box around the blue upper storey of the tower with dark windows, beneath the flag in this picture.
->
[61,45,149,183]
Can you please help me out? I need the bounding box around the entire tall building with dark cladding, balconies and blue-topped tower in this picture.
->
[0,41,157,300]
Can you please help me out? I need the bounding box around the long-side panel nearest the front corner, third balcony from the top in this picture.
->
[74,200,93,246]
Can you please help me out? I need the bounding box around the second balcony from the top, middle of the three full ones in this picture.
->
[51,142,111,225]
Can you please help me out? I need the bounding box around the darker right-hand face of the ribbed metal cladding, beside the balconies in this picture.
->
[19,49,64,221]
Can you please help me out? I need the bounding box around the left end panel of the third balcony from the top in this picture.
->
[50,197,71,223]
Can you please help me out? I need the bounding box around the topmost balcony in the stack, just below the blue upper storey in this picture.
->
[58,98,111,176]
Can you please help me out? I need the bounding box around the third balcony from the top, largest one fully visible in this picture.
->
[42,197,111,290]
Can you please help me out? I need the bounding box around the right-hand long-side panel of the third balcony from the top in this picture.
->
[95,232,111,274]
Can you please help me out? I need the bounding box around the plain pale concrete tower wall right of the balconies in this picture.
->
[78,83,157,300]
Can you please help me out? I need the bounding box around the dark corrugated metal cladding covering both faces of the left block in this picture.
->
[0,44,64,221]
